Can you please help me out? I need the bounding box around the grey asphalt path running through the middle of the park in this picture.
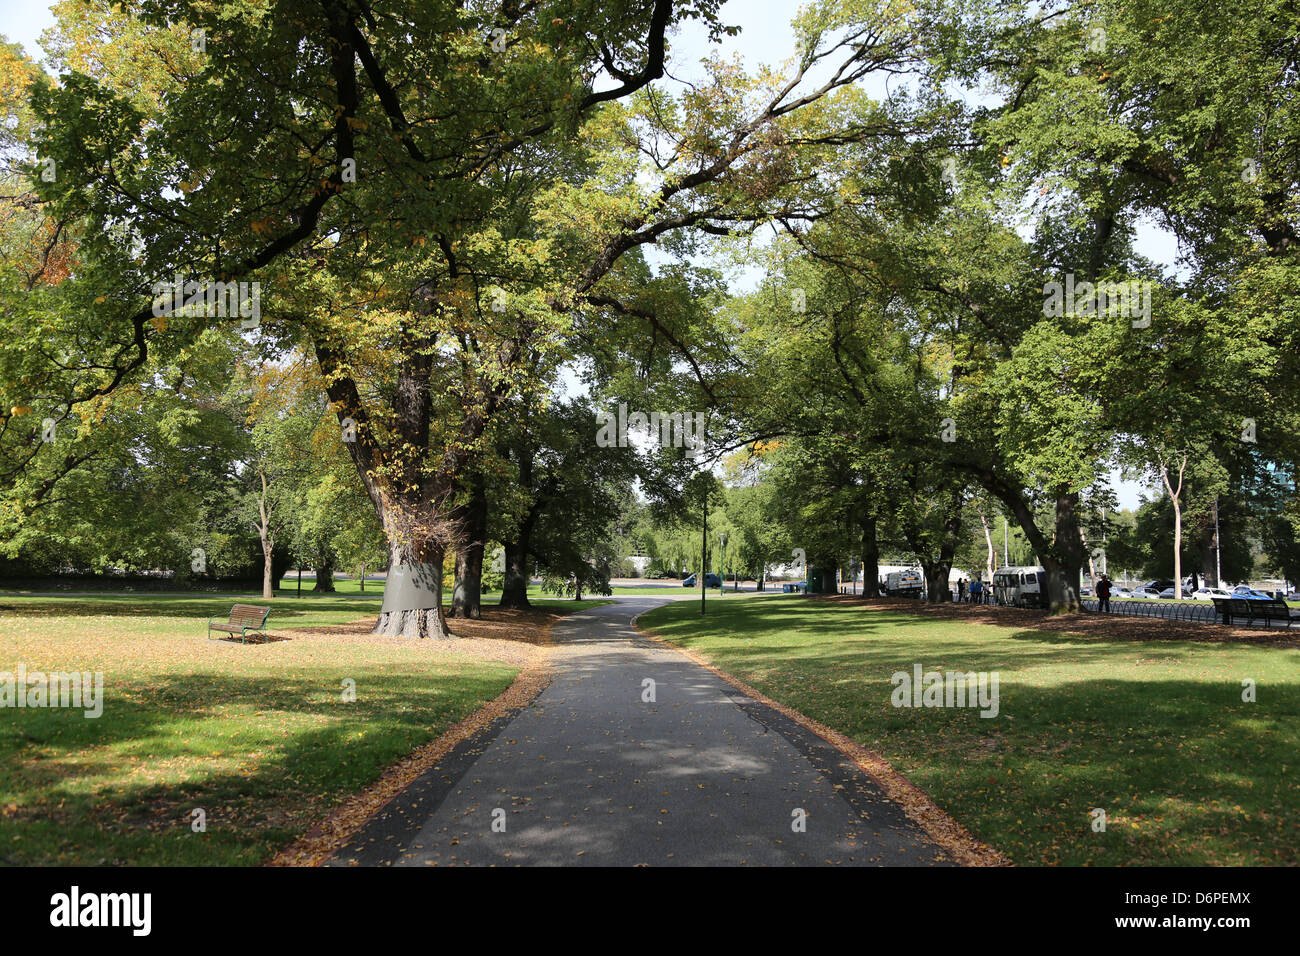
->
[326,597,952,866]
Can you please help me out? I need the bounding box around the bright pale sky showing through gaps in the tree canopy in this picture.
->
[0,0,1159,507]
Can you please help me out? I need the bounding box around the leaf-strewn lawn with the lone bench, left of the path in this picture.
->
[0,594,538,865]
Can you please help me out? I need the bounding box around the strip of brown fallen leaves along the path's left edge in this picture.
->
[263,661,554,866]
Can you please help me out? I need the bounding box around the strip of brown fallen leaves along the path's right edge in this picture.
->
[632,615,1014,866]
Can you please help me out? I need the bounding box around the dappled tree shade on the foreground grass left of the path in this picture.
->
[0,667,512,862]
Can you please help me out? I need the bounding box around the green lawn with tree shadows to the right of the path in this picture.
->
[640,596,1300,865]
